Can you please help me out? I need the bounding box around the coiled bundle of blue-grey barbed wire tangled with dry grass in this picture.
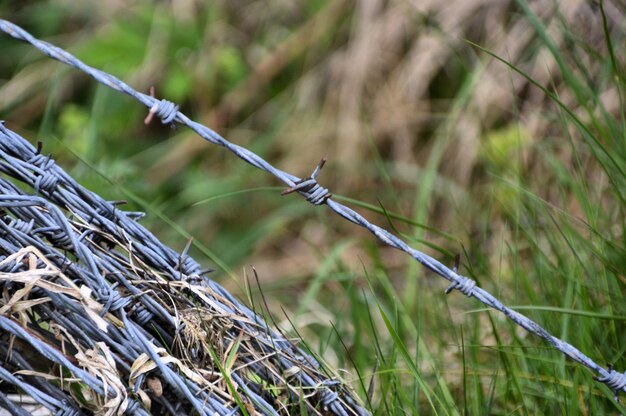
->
[0,128,367,416]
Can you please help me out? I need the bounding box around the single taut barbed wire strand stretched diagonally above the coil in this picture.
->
[0,20,626,406]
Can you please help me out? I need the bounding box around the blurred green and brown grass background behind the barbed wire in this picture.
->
[0,0,626,414]
